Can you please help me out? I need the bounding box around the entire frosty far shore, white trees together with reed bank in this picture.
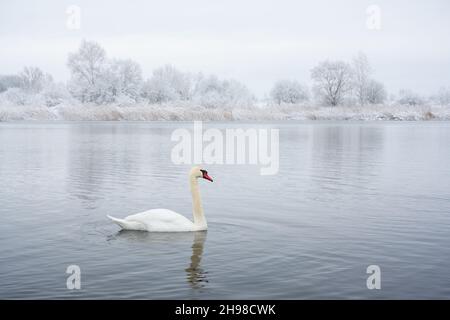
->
[0,40,450,122]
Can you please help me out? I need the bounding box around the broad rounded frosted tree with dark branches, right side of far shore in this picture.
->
[311,61,353,106]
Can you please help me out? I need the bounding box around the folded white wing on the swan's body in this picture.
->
[124,209,195,232]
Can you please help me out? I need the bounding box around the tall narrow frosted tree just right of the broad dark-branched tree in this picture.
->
[352,52,372,106]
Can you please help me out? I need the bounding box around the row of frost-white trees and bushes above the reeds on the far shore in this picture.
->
[0,40,450,108]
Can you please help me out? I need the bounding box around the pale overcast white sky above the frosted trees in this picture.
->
[0,0,450,97]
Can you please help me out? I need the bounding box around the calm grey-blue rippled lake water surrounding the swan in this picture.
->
[0,122,450,299]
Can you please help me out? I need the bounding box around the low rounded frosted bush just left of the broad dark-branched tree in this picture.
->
[270,80,308,104]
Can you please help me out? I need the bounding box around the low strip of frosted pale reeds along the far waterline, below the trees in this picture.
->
[0,104,450,121]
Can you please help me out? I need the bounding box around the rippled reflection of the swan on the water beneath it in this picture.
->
[108,230,208,289]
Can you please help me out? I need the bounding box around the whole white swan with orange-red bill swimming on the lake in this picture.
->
[107,167,213,232]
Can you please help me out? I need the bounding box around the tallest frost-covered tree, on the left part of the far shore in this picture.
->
[67,40,108,103]
